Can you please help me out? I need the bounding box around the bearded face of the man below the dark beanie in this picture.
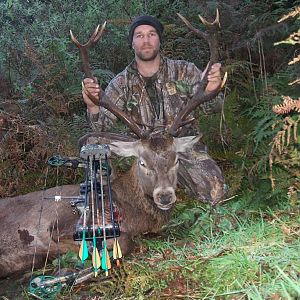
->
[132,25,160,61]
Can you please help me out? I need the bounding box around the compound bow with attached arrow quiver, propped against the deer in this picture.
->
[29,144,122,299]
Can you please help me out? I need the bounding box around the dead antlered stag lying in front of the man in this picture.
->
[0,11,226,278]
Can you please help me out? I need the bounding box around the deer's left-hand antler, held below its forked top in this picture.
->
[70,22,148,138]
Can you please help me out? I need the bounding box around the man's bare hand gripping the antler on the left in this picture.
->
[82,78,101,114]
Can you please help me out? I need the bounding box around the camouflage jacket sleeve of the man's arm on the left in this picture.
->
[87,74,126,131]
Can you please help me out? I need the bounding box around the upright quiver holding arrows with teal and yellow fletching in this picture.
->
[73,144,121,276]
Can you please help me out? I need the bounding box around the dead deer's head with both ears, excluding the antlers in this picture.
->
[110,135,200,210]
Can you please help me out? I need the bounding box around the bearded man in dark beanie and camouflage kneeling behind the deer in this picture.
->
[82,16,224,204]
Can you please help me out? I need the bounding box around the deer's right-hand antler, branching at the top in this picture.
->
[169,9,227,136]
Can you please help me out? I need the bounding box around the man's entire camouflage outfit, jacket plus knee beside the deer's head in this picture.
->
[88,57,224,204]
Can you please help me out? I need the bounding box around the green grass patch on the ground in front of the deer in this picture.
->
[1,193,300,300]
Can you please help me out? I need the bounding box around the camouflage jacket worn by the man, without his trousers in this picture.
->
[88,57,223,132]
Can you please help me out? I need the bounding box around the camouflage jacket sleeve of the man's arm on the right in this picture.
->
[187,63,224,115]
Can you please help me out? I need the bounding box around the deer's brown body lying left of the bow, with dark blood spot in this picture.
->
[0,185,79,278]
